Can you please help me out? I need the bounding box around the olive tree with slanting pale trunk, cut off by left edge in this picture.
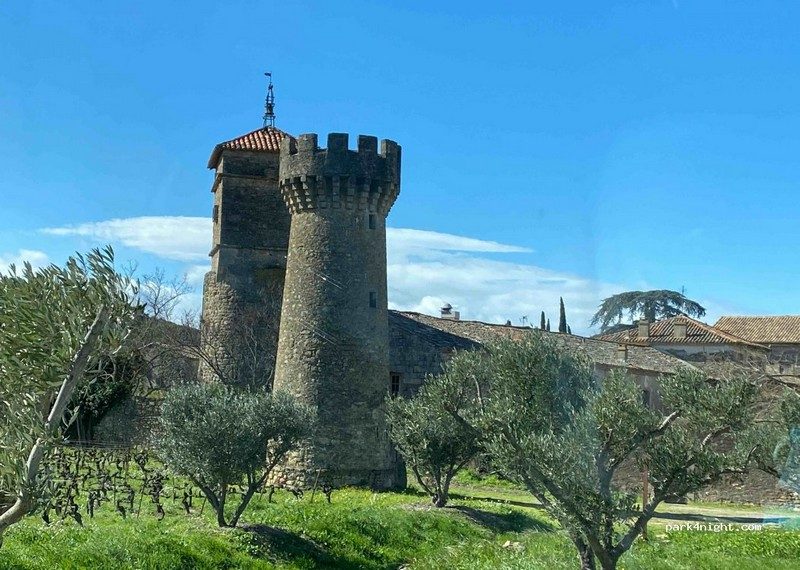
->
[0,248,136,541]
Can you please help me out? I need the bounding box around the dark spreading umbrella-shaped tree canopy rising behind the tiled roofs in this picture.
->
[591,289,706,332]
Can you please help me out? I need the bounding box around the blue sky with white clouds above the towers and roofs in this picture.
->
[0,0,800,331]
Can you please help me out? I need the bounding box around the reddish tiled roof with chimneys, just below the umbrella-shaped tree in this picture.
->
[595,316,766,348]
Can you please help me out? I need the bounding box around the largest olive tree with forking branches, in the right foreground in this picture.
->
[443,333,756,569]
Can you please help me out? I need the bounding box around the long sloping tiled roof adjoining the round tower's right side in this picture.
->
[389,311,692,374]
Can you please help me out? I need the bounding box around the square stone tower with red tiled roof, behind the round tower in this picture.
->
[200,127,290,385]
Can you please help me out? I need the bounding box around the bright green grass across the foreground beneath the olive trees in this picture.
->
[0,481,800,570]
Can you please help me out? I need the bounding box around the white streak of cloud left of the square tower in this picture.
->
[42,216,211,261]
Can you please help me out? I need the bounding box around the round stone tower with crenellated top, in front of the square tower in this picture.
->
[275,133,401,488]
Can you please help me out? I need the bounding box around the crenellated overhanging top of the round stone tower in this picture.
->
[279,133,401,216]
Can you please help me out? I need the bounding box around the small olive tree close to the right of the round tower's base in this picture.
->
[387,353,480,507]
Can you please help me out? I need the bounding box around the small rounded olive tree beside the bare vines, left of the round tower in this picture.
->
[155,383,313,527]
